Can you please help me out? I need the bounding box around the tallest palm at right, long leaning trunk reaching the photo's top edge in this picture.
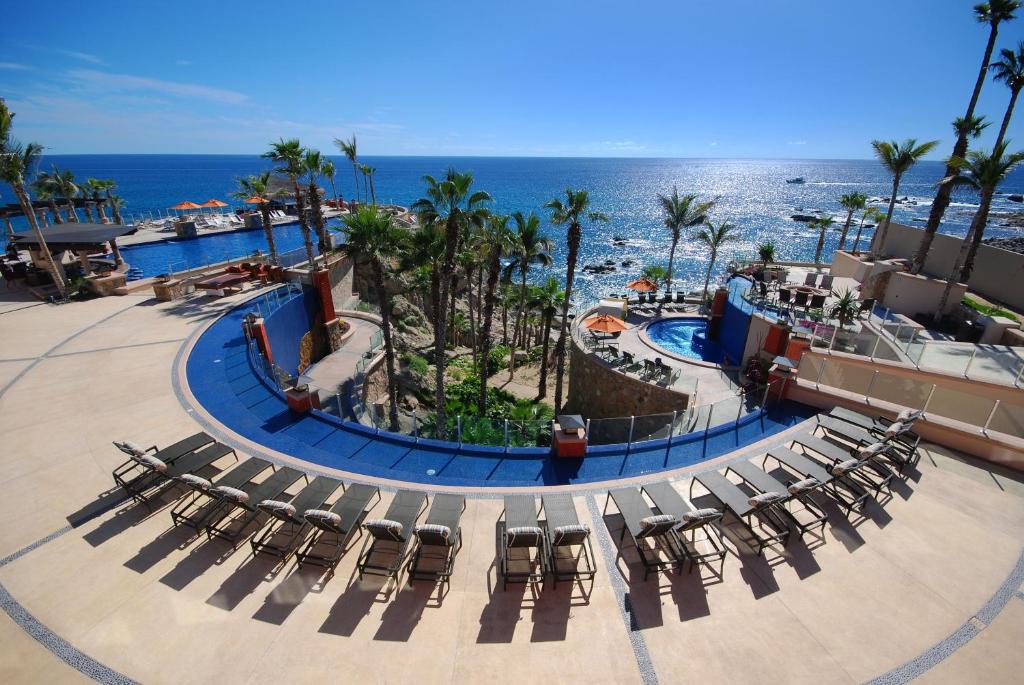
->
[913,0,1021,273]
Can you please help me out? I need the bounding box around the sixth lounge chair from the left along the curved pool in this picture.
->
[295,483,381,573]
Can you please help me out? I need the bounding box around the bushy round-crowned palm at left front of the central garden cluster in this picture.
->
[341,207,402,431]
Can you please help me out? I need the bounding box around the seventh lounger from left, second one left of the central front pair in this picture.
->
[356,490,427,579]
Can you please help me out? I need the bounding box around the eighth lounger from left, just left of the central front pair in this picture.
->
[409,494,466,584]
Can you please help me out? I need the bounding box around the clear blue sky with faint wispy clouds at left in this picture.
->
[0,0,1024,159]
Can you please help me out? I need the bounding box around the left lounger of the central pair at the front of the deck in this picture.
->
[497,495,547,590]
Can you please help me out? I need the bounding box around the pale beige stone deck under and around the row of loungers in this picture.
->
[0,286,1024,683]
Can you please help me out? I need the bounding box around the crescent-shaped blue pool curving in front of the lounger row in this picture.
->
[185,284,814,487]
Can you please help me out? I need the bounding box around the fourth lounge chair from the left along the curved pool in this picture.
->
[204,467,309,547]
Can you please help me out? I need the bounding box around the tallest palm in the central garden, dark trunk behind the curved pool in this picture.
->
[412,169,490,439]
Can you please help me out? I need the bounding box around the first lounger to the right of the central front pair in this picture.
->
[604,487,686,581]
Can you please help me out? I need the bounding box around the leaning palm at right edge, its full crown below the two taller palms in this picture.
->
[935,141,1024,318]
